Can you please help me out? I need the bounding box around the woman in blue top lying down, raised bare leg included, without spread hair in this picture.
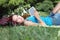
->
[0,2,60,26]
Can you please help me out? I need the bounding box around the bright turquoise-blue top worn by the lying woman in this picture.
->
[26,16,53,26]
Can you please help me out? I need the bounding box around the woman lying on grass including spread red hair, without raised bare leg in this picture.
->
[0,10,60,26]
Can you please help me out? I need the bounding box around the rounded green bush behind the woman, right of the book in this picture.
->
[35,0,54,12]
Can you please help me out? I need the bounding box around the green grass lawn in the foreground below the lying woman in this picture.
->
[0,26,60,40]
